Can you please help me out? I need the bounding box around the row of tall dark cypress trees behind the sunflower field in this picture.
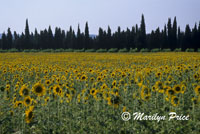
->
[0,15,200,51]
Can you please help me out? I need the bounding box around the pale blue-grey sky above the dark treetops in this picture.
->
[0,0,200,34]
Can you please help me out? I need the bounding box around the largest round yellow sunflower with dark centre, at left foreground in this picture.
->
[32,83,46,96]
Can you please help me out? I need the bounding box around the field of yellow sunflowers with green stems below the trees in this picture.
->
[0,52,200,134]
